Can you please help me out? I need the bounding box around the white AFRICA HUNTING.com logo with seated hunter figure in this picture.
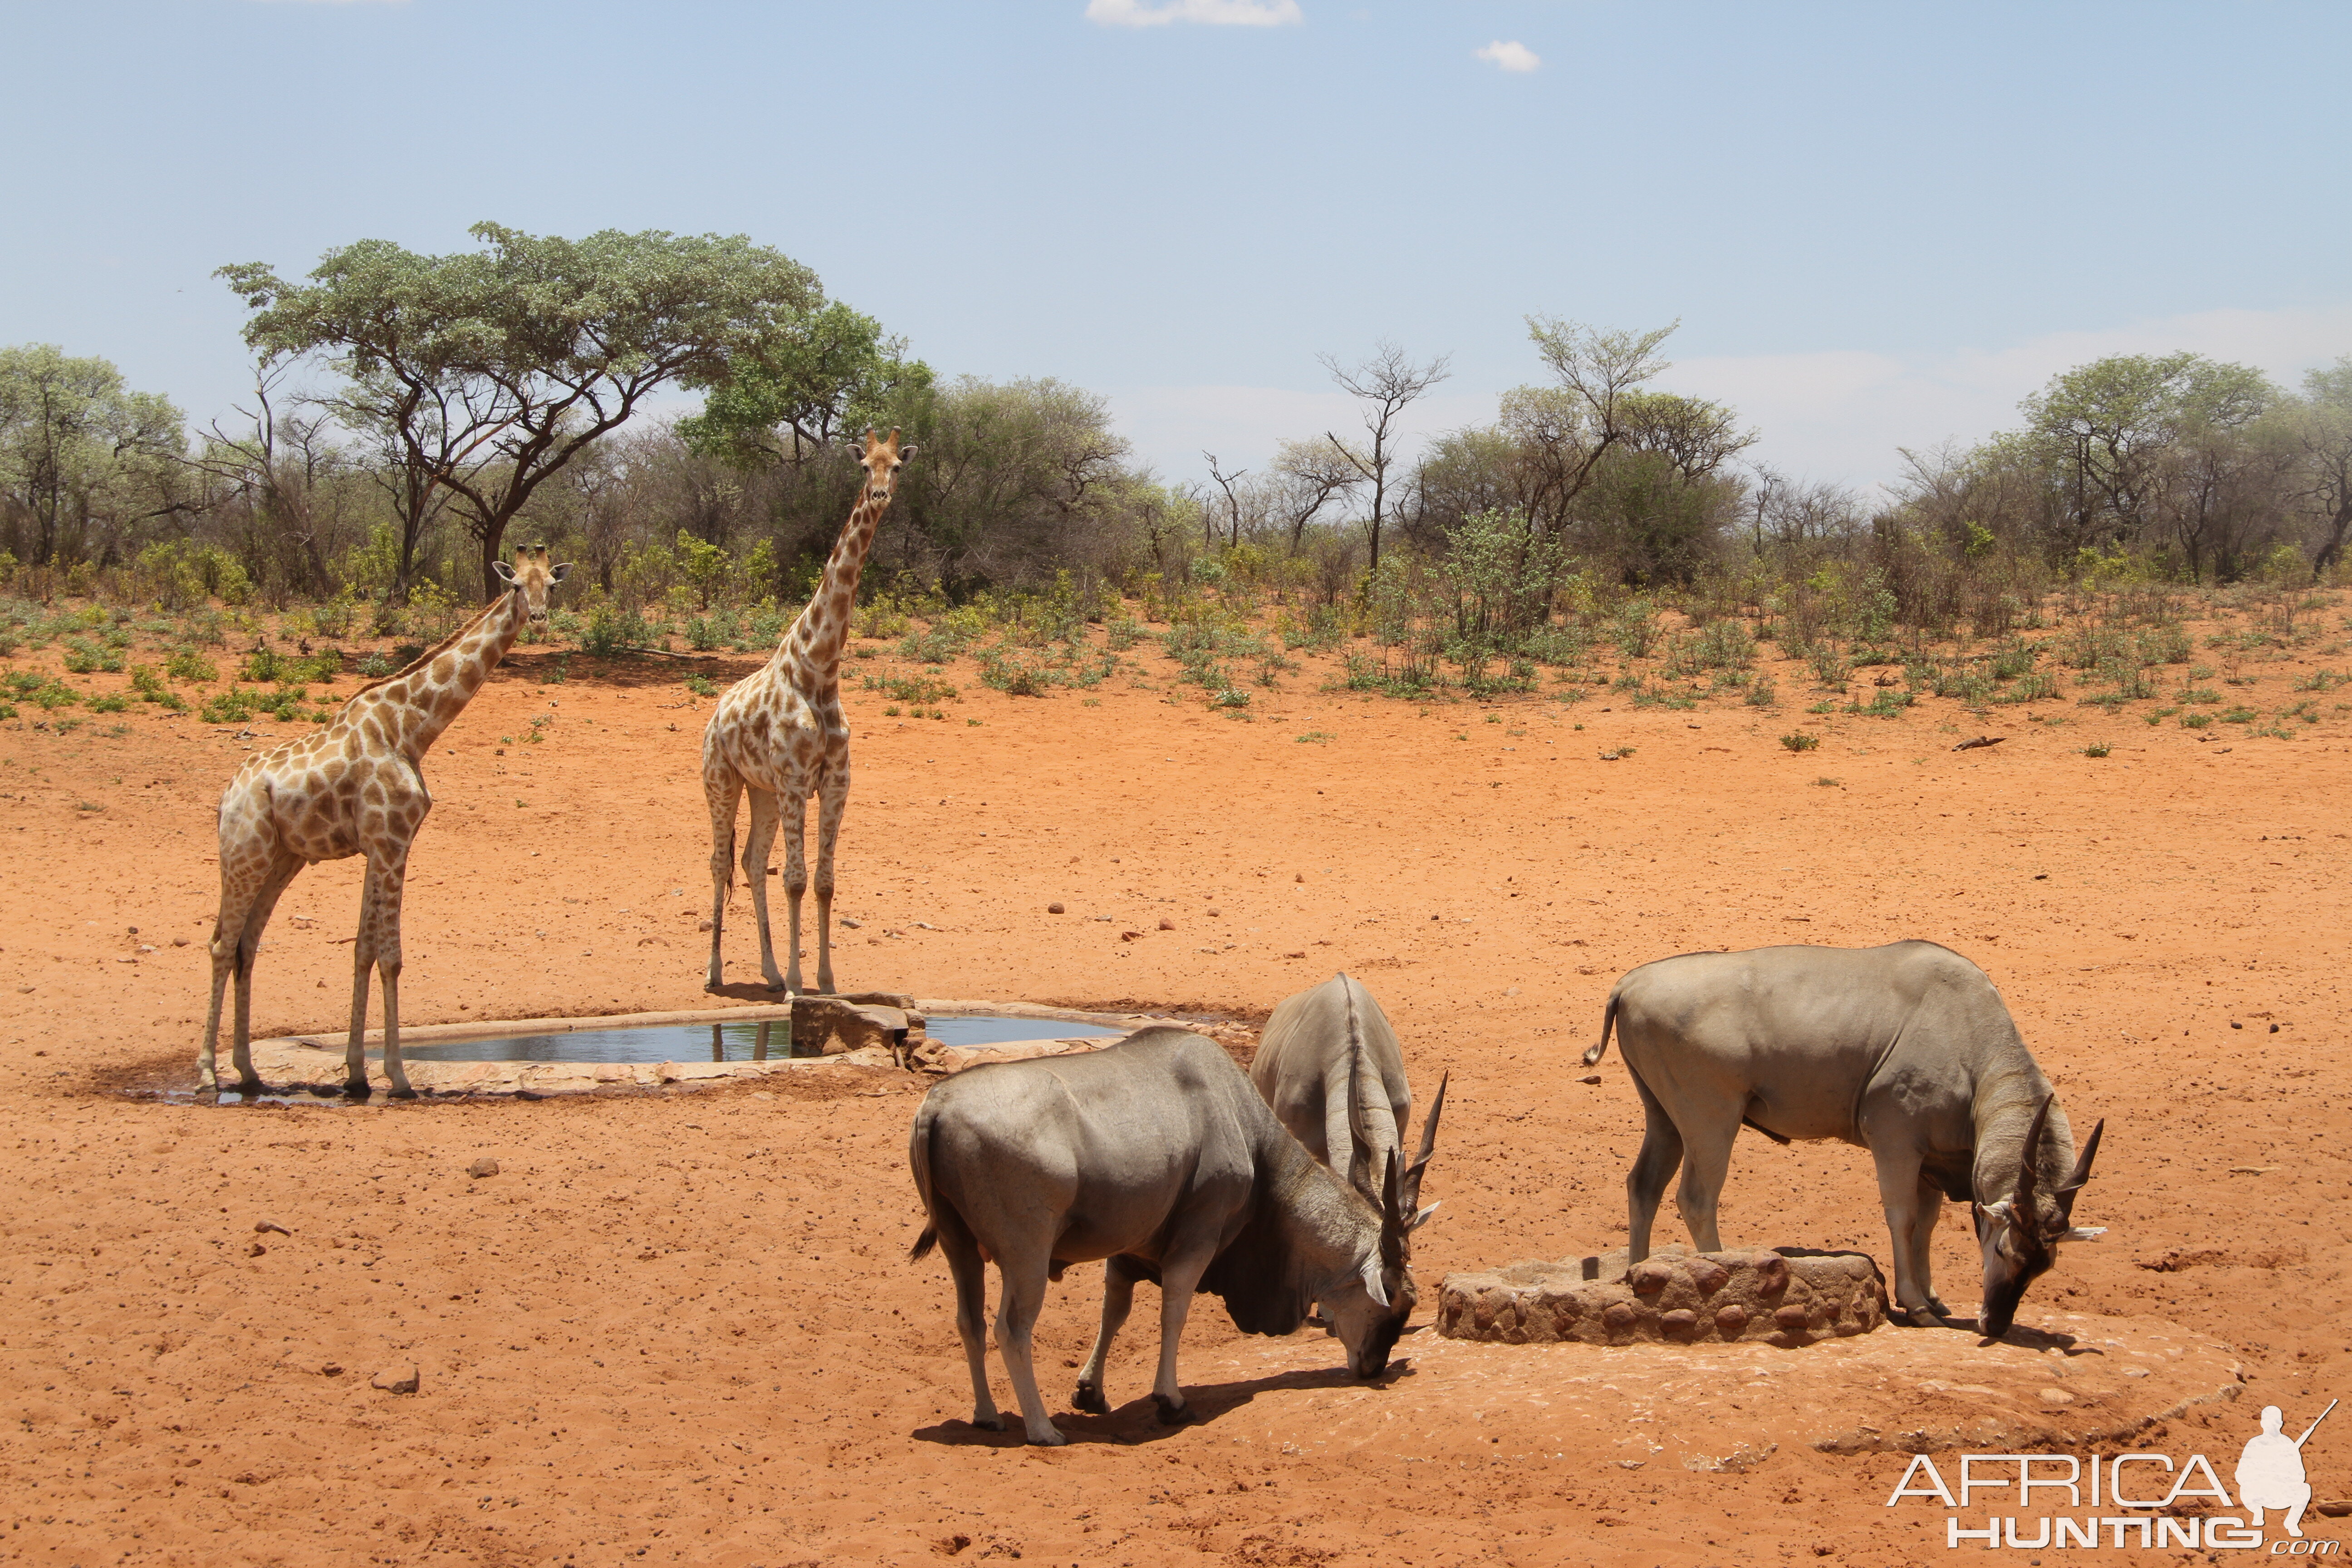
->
[1886,1399,2342,1556]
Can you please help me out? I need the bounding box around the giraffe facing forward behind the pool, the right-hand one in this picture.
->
[703,430,915,997]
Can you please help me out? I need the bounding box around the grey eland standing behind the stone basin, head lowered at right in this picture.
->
[1585,943,2107,1338]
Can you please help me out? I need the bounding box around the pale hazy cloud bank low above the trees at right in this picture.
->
[1661,306,2352,484]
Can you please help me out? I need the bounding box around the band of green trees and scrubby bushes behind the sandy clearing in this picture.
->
[0,223,2352,734]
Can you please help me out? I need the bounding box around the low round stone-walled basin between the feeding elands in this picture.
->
[1437,1246,1886,1349]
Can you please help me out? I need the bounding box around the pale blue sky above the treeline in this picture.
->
[0,0,2352,482]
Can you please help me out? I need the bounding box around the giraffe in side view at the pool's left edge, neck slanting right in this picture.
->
[195,545,572,1100]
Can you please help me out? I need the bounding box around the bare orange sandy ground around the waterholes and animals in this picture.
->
[0,597,2352,1568]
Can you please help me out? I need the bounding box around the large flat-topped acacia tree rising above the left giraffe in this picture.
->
[216,223,823,593]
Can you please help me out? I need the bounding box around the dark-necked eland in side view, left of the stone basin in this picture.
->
[908,1027,1444,1446]
